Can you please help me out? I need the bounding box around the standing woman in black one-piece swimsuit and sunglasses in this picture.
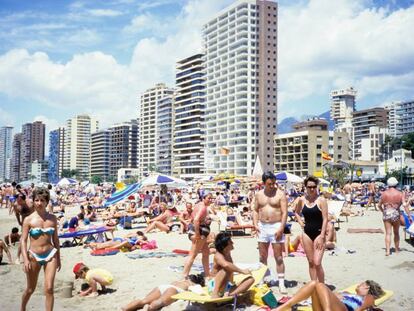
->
[295,176,328,283]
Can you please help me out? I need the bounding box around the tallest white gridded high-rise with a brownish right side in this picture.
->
[203,0,278,175]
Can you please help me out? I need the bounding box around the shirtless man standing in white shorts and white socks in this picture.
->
[253,172,287,294]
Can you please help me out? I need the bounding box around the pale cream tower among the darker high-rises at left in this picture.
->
[63,115,99,179]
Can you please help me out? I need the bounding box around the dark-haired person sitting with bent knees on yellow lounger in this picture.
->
[207,232,254,298]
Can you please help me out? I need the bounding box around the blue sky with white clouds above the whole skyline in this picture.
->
[0,0,414,139]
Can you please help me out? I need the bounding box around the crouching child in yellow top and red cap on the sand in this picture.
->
[73,262,114,296]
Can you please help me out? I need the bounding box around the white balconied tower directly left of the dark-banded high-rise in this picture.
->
[138,83,174,176]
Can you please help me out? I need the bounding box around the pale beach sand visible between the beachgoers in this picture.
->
[0,208,414,311]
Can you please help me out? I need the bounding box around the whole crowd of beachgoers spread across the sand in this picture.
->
[0,172,414,310]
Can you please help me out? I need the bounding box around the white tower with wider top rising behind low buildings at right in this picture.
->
[331,87,357,130]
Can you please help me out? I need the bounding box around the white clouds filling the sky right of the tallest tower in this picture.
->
[278,0,414,111]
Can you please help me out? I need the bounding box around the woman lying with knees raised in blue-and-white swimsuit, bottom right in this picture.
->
[274,280,384,311]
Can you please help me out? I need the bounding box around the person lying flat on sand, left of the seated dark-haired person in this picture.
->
[122,274,204,311]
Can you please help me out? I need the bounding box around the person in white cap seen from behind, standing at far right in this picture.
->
[378,177,412,256]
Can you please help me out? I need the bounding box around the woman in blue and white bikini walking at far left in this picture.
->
[21,188,60,311]
